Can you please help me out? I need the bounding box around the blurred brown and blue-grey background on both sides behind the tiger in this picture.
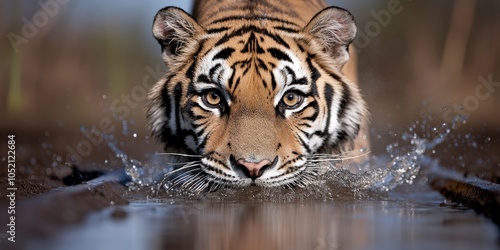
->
[0,0,500,193]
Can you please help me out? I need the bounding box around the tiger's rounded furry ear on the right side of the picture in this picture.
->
[304,7,357,69]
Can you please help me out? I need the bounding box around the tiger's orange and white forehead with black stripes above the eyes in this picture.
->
[196,26,309,97]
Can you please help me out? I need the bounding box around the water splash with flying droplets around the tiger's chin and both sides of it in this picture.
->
[92,107,467,200]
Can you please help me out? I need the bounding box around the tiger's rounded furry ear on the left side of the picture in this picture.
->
[153,7,204,65]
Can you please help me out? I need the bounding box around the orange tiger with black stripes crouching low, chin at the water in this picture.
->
[147,0,369,190]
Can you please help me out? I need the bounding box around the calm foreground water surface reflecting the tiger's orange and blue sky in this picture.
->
[33,197,498,250]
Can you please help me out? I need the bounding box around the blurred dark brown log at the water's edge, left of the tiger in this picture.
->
[0,170,129,240]
